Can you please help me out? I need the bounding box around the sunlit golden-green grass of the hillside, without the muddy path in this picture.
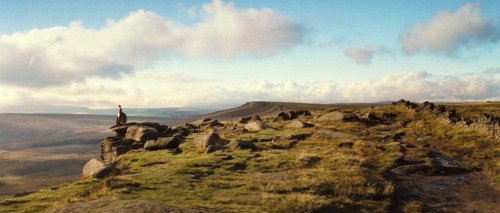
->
[0,104,500,212]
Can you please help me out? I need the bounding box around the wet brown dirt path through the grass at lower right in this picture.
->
[389,143,500,212]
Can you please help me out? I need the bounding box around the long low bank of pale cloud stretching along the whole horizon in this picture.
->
[0,68,500,111]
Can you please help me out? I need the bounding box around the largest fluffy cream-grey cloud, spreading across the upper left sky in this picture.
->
[0,0,304,88]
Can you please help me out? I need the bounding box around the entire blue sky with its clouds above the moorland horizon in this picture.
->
[0,0,500,112]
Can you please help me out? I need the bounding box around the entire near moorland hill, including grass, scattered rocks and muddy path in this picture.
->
[0,100,500,212]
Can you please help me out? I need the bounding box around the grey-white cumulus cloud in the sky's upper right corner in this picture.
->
[400,4,500,55]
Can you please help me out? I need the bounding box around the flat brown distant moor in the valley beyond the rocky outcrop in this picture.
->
[0,114,181,196]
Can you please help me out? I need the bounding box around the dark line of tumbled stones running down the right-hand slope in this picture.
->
[392,99,500,140]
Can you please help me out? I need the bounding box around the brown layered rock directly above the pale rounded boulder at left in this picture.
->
[101,137,134,163]
